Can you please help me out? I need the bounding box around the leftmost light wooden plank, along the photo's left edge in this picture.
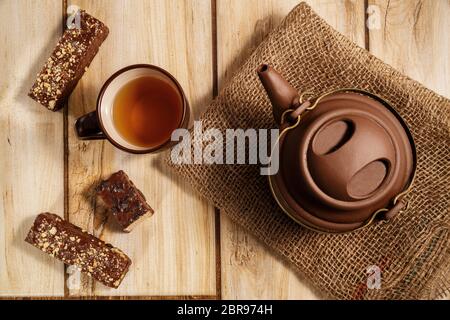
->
[0,0,64,296]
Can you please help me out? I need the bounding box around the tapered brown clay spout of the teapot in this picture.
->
[257,64,299,124]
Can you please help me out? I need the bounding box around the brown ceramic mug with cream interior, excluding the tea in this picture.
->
[75,64,190,154]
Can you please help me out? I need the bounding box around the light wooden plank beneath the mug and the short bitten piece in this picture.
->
[68,0,216,296]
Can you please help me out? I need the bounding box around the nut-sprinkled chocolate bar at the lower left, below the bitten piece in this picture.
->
[25,213,131,288]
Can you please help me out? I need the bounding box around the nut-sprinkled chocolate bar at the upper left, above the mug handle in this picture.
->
[28,10,109,111]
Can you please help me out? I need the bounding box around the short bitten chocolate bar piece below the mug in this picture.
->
[96,170,153,232]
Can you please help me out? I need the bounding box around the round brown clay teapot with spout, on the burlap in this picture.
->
[258,65,416,233]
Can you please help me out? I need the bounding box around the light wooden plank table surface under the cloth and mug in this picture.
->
[0,0,450,299]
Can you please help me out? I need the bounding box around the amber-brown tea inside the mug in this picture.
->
[113,76,183,148]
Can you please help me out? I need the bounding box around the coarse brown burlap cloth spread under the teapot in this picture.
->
[167,3,450,299]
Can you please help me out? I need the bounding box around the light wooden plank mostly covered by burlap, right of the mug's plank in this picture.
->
[217,0,364,299]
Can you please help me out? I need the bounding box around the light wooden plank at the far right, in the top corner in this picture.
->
[369,0,450,299]
